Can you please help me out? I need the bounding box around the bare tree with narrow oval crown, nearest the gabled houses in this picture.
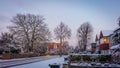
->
[77,22,93,51]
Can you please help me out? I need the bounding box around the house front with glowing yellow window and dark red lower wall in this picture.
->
[95,31,110,54]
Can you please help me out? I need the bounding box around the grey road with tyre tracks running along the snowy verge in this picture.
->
[0,56,59,68]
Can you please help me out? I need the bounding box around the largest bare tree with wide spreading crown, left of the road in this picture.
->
[8,14,50,52]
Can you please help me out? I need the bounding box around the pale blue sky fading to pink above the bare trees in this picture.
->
[0,0,120,45]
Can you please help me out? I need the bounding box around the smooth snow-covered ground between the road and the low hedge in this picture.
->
[10,56,65,68]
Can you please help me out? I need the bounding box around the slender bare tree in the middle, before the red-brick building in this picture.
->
[54,22,71,55]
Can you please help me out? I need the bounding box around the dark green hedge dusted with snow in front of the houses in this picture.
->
[70,55,112,62]
